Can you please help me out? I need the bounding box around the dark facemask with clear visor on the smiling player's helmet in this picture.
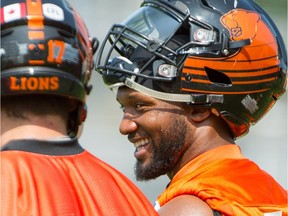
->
[97,1,250,104]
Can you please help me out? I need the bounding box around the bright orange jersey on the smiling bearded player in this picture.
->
[157,145,288,216]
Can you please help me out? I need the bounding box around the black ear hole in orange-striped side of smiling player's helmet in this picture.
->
[204,67,232,87]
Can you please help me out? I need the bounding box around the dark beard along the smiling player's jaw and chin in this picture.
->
[135,118,187,181]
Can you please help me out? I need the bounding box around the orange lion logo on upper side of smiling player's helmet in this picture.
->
[220,9,262,41]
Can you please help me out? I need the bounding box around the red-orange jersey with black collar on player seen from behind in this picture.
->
[1,140,156,216]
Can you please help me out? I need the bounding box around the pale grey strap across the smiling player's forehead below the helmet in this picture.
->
[109,77,224,105]
